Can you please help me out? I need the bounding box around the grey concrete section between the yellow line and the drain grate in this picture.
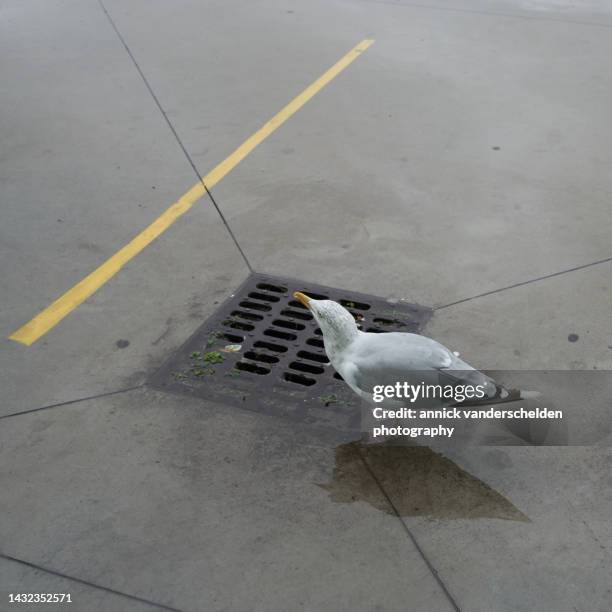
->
[0,198,247,414]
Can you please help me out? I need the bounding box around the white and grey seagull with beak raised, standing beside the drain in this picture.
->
[293,291,539,407]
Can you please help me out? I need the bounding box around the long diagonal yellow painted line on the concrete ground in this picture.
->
[9,39,374,346]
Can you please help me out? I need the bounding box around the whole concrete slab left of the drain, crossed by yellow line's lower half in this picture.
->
[0,1,247,414]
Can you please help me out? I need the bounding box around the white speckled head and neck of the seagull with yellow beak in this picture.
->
[293,291,359,359]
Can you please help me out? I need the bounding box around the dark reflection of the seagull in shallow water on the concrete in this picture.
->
[319,441,529,522]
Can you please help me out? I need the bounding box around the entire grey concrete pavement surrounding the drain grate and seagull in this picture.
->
[0,0,612,612]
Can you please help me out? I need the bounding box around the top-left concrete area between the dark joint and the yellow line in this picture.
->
[0,0,195,320]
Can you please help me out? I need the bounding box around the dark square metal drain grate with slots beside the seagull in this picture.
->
[149,274,432,431]
